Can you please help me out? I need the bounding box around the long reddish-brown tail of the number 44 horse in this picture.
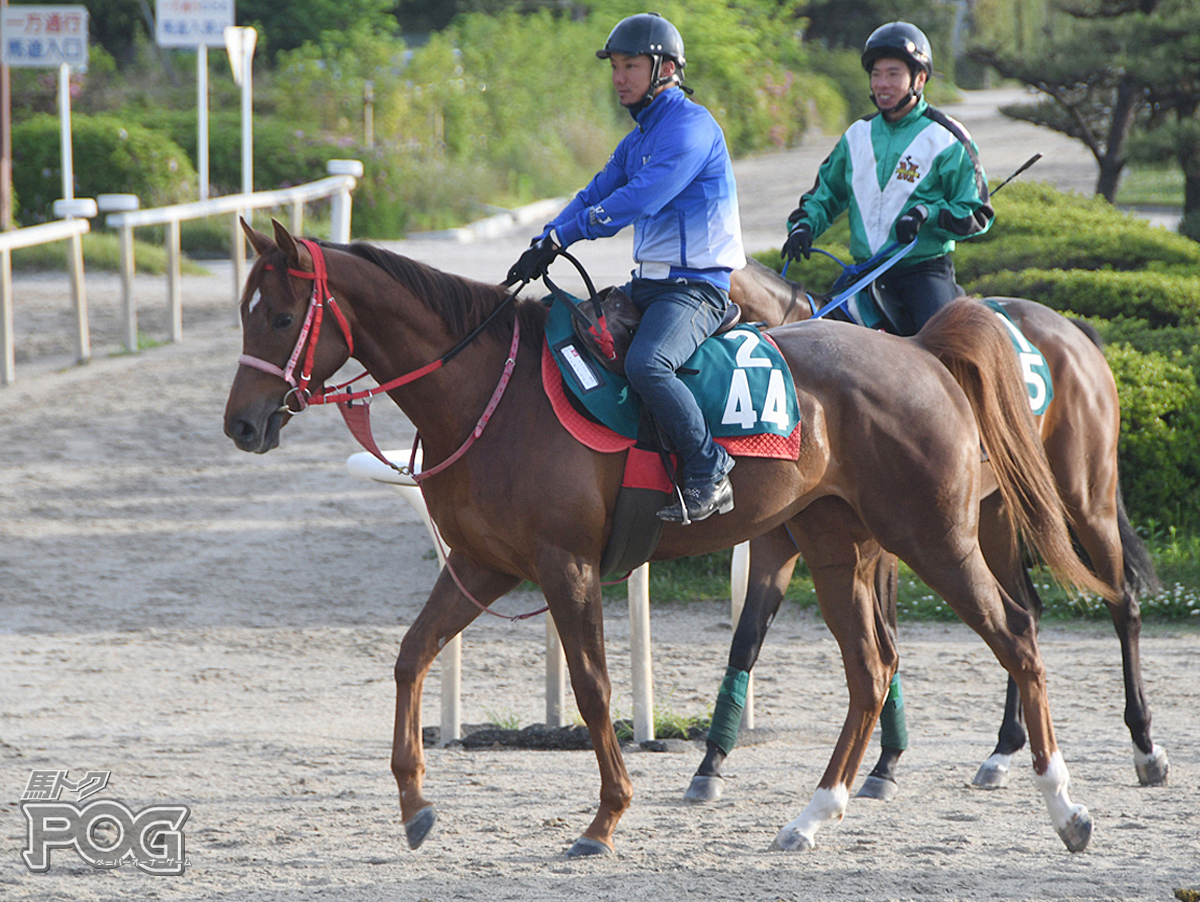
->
[916,299,1116,601]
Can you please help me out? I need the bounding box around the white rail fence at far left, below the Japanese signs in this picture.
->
[0,160,362,385]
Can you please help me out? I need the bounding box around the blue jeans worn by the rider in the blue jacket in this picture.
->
[625,278,733,488]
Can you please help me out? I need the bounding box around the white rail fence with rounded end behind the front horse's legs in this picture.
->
[346,451,755,745]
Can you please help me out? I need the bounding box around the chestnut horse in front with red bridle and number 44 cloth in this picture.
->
[224,223,1103,855]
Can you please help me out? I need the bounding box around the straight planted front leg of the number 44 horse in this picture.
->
[538,553,634,858]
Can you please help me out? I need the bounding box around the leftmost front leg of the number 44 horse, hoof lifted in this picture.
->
[391,554,520,849]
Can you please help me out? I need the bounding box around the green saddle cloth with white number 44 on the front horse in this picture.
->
[546,301,800,439]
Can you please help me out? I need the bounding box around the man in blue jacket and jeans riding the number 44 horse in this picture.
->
[509,13,745,523]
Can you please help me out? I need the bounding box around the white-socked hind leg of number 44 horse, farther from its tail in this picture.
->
[772,498,899,852]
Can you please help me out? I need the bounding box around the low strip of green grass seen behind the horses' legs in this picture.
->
[604,532,1200,625]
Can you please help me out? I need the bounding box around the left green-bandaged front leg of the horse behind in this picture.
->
[683,527,799,802]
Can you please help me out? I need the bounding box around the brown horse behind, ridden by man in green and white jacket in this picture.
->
[705,258,1170,801]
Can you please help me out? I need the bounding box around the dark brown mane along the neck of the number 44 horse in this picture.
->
[319,241,547,350]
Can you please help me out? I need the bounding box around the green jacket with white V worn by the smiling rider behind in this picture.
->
[787,98,995,269]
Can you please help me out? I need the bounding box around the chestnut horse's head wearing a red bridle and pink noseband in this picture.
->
[224,220,352,453]
